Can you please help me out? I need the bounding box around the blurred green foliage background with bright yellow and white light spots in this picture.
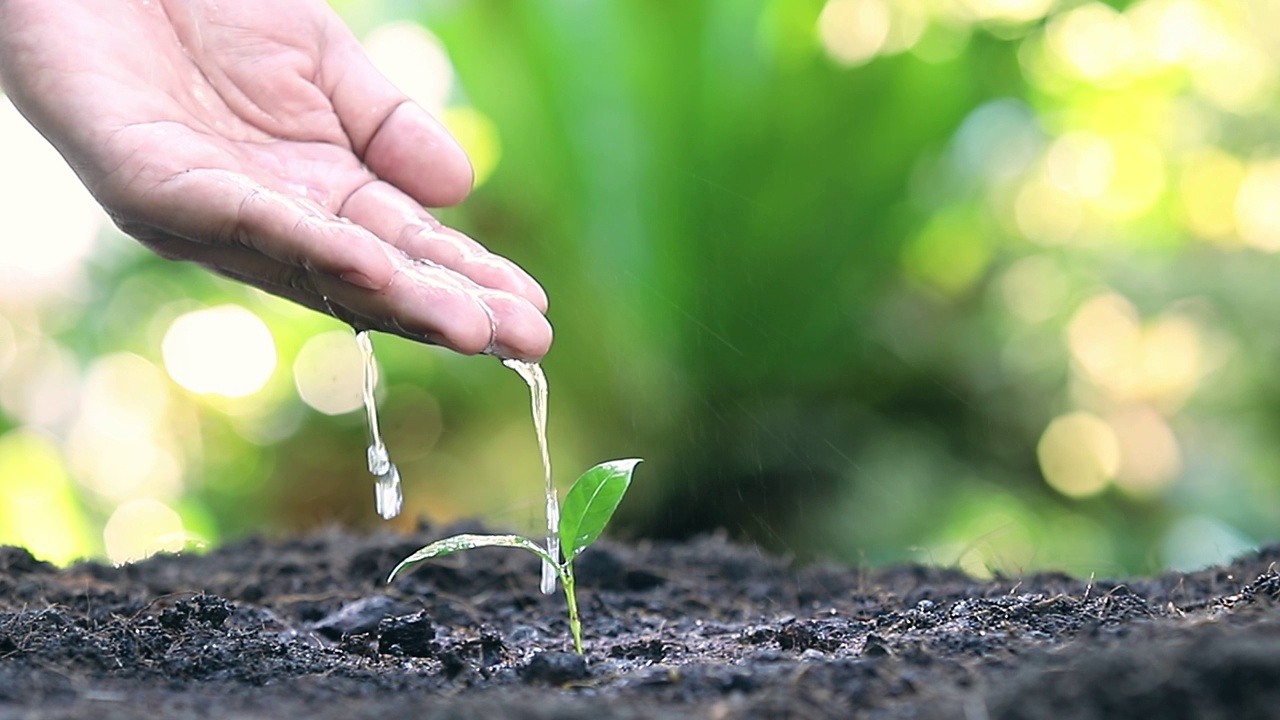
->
[0,0,1280,575]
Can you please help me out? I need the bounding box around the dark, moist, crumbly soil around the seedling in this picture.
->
[0,527,1280,720]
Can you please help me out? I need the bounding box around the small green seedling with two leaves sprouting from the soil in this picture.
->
[387,459,640,655]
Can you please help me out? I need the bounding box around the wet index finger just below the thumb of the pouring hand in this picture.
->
[340,181,547,313]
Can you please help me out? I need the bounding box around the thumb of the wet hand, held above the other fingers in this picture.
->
[323,23,474,208]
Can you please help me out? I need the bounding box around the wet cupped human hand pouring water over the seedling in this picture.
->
[0,0,552,360]
